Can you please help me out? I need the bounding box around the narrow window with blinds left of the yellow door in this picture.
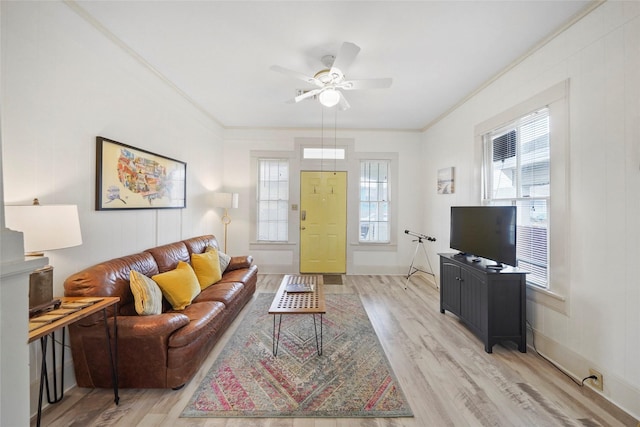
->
[257,159,289,242]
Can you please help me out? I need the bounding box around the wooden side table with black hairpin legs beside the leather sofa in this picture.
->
[28,297,120,427]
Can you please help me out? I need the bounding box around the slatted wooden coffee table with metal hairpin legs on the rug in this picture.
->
[269,274,326,356]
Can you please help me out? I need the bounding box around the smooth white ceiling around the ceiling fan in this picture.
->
[75,0,591,130]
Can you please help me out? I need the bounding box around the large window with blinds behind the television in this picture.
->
[483,108,551,288]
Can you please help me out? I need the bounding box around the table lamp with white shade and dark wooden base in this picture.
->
[5,199,82,316]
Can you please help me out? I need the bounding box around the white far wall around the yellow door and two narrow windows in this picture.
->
[224,129,428,274]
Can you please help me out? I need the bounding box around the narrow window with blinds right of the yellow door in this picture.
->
[359,160,390,243]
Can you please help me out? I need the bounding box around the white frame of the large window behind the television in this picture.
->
[474,79,571,314]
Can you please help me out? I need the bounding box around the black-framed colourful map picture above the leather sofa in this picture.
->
[96,136,187,210]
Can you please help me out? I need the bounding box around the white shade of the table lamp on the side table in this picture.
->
[5,205,82,252]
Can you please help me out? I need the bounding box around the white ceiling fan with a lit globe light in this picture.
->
[271,42,391,110]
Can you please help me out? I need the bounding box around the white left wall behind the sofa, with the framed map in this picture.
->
[0,2,223,418]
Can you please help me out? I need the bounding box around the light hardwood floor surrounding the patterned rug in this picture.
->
[37,275,639,427]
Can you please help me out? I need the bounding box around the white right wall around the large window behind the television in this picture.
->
[424,2,640,417]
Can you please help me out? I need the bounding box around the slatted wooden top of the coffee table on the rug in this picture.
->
[269,274,326,314]
